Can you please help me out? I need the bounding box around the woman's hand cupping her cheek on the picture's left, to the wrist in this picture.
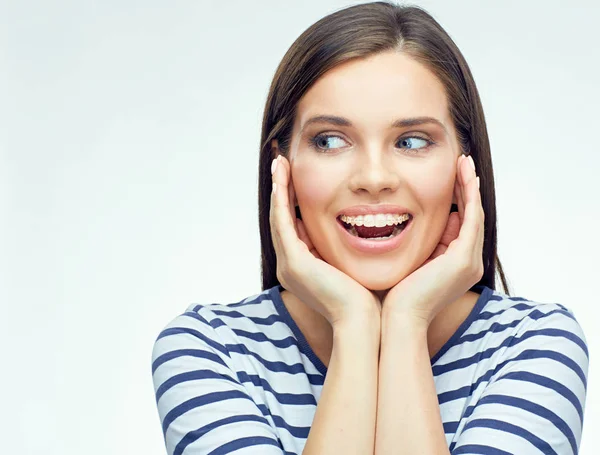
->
[269,155,381,327]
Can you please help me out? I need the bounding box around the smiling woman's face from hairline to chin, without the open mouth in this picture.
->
[290,52,460,291]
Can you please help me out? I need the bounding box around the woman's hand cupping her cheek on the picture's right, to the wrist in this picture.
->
[382,154,484,328]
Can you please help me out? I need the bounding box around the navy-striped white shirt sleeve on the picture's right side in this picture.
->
[450,305,589,455]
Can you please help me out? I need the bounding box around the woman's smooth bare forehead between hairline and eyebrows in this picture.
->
[295,52,450,131]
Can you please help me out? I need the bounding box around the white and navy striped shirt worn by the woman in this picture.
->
[152,286,589,455]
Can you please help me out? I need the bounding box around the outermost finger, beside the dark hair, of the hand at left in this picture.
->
[270,155,298,260]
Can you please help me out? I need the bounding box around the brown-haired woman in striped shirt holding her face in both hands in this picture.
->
[152,2,588,455]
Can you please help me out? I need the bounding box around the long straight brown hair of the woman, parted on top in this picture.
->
[258,1,509,294]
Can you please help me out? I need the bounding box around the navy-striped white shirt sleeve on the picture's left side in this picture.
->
[152,311,283,455]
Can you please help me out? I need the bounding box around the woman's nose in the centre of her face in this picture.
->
[350,149,400,196]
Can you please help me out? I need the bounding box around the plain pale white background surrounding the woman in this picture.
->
[0,0,600,455]
